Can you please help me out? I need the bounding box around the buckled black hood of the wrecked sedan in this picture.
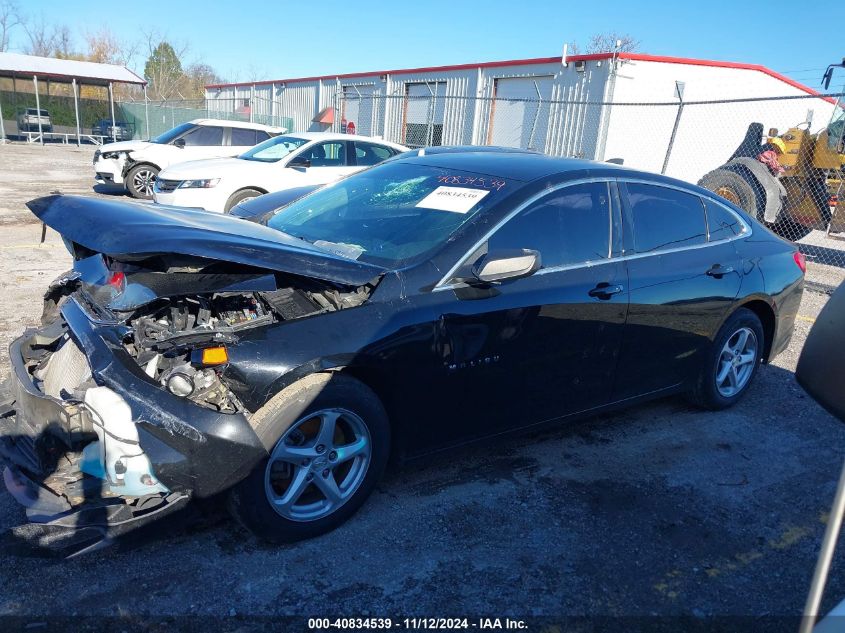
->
[27,195,385,286]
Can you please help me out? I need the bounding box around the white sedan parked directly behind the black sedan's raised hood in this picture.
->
[153,132,408,213]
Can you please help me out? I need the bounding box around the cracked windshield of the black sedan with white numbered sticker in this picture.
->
[267,162,523,268]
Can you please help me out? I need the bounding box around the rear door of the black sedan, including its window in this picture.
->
[613,182,742,400]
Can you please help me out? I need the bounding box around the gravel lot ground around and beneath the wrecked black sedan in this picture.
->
[0,146,845,630]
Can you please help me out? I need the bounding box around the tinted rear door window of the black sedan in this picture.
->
[626,182,707,253]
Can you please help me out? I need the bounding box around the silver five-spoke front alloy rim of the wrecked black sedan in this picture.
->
[264,409,372,521]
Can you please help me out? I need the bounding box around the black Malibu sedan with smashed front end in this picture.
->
[0,151,804,542]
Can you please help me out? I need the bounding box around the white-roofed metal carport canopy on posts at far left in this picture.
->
[0,53,147,145]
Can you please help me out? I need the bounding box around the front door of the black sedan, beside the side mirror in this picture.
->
[426,182,628,443]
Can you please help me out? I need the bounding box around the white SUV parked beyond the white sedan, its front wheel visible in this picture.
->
[94,119,286,200]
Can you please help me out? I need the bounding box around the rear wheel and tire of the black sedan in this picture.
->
[690,308,766,411]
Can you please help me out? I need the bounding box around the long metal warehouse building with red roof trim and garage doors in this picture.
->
[206,53,835,181]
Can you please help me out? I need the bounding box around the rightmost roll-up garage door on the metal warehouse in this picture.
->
[488,77,552,152]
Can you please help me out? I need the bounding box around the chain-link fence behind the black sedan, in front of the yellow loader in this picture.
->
[329,89,845,284]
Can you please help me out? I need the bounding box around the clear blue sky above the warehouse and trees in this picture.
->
[4,0,845,89]
